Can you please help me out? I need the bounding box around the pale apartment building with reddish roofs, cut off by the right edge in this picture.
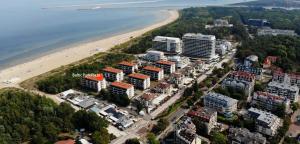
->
[272,71,300,88]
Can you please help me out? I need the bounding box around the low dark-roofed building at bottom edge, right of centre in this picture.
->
[228,128,267,144]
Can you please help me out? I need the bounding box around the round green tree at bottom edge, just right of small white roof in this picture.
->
[92,128,110,144]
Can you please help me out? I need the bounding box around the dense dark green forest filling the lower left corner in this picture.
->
[0,89,110,144]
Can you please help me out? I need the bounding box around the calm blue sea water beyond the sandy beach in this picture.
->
[0,0,253,69]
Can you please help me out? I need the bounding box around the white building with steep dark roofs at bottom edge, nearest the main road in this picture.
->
[173,117,201,144]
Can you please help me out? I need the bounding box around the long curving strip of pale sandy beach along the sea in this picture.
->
[0,10,179,88]
